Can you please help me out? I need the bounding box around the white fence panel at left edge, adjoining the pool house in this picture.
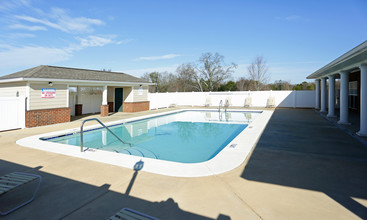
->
[0,97,25,131]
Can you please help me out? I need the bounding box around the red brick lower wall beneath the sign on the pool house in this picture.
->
[25,108,70,128]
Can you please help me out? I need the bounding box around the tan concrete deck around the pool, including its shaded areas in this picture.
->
[0,109,367,219]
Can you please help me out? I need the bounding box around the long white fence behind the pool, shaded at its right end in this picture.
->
[148,90,316,109]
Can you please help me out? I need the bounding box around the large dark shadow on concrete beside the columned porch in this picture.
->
[241,109,367,219]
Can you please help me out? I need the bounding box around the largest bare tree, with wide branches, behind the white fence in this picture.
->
[196,53,237,91]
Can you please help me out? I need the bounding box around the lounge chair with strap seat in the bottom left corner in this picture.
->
[0,172,42,215]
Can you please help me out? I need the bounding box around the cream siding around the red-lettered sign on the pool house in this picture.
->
[29,82,68,110]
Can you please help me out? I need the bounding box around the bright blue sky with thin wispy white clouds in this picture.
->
[0,0,367,83]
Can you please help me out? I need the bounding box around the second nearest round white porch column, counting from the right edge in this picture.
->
[338,71,349,124]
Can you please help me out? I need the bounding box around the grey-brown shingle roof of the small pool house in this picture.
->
[0,65,149,83]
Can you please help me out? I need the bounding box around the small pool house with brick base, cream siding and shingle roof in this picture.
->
[0,65,153,127]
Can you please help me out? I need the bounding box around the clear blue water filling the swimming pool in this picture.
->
[42,111,259,163]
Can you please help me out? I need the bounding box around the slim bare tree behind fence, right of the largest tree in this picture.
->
[247,56,269,91]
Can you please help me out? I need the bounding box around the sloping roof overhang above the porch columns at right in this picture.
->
[307,41,367,79]
